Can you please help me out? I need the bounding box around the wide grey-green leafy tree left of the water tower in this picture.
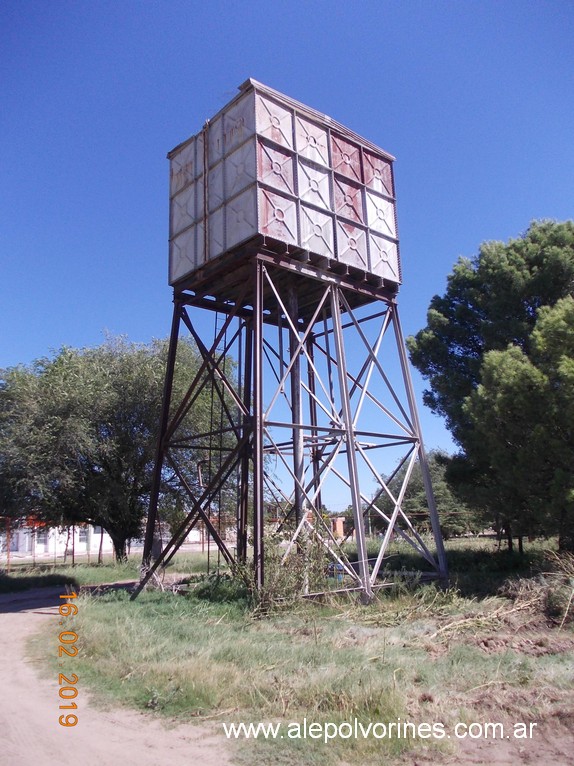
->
[0,339,218,559]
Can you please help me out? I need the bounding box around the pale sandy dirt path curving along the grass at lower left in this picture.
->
[0,588,231,766]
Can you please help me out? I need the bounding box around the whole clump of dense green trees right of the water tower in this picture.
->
[408,221,574,547]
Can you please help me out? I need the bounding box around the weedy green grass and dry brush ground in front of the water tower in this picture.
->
[24,541,574,766]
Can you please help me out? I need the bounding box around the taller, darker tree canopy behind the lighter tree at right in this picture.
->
[407,221,574,446]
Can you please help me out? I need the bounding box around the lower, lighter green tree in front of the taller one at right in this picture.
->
[464,296,574,550]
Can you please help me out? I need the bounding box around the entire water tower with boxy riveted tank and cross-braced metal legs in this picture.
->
[135,79,447,599]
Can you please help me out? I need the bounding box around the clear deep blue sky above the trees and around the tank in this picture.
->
[0,0,574,456]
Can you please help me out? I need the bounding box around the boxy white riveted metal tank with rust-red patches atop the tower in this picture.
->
[168,80,401,286]
